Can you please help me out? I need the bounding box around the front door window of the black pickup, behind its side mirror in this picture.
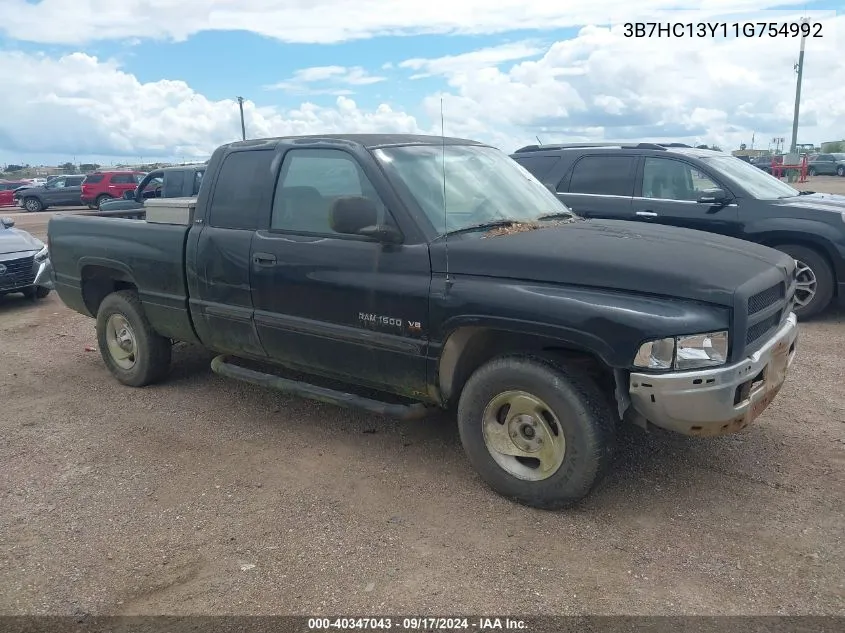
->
[270,149,389,235]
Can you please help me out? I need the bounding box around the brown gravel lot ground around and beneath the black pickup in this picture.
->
[0,177,845,615]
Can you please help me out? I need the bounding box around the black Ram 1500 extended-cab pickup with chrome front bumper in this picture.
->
[48,135,798,508]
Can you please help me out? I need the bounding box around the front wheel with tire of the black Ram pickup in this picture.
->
[458,355,616,510]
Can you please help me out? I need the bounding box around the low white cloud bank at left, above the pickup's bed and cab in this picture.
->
[0,52,421,162]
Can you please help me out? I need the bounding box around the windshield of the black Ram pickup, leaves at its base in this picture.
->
[374,145,571,235]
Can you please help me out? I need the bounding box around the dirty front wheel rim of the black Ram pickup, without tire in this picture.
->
[482,391,566,481]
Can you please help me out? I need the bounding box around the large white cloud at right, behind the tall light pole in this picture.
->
[408,16,845,149]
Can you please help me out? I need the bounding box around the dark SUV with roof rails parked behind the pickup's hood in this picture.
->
[511,143,845,317]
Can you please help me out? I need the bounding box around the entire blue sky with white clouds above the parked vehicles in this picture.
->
[0,0,845,164]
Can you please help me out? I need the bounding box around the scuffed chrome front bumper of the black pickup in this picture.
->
[629,313,798,436]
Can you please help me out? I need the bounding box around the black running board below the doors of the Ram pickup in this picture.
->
[211,354,439,420]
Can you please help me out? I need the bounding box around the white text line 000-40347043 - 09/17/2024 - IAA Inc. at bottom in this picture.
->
[308,616,528,633]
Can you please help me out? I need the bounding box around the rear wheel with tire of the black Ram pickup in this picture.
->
[97,290,171,387]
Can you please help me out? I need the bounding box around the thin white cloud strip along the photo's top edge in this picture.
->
[0,0,816,44]
